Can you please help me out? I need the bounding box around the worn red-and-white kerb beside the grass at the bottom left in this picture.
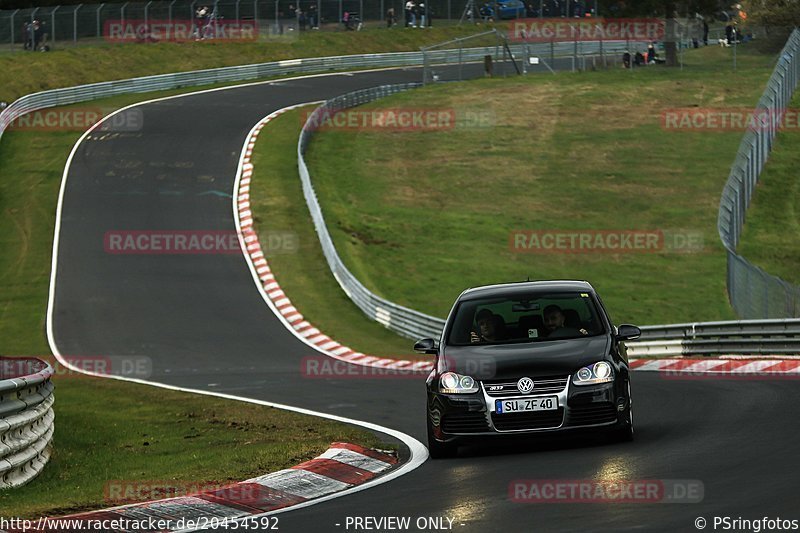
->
[44,442,398,531]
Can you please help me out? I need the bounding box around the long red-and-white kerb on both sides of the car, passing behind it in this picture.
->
[234,106,800,375]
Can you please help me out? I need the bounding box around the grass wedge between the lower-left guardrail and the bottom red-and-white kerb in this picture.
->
[0,376,385,518]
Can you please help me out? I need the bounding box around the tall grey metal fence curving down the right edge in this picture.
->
[717,29,800,318]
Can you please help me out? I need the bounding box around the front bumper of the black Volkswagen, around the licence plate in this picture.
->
[428,377,630,441]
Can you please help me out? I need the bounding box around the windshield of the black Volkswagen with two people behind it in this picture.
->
[447,291,605,346]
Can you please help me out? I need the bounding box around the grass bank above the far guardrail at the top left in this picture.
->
[0,26,494,102]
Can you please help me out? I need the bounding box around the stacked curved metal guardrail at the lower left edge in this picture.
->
[0,358,55,489]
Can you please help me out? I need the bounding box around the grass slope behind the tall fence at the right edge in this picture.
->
[738,91,800,284]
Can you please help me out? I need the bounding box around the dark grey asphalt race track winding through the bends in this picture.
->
[48,70,800,533]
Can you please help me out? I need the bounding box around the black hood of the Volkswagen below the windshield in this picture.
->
[439,335,611,380]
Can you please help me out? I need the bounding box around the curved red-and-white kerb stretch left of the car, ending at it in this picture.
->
[233,102,433,373]
